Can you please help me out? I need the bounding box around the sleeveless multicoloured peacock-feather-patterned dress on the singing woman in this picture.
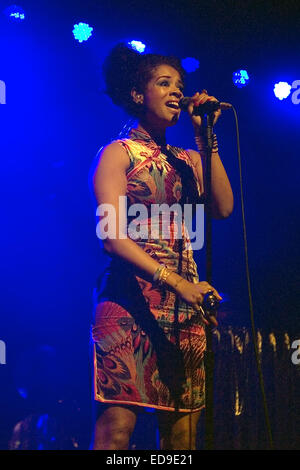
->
[92,129,206,412]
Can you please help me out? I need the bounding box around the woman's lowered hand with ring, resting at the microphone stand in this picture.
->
[176,279,222,326]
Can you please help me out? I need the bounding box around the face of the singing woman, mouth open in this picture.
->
[139,65,183,128]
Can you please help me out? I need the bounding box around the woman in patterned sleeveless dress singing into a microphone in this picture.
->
[92,44,233,450]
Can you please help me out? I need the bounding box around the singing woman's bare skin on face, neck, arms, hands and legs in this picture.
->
[93,64,233,450]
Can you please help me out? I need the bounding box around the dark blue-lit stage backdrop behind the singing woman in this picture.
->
[0,0,300,448]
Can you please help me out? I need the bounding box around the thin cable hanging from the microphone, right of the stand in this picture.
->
[232,106,273,450]
